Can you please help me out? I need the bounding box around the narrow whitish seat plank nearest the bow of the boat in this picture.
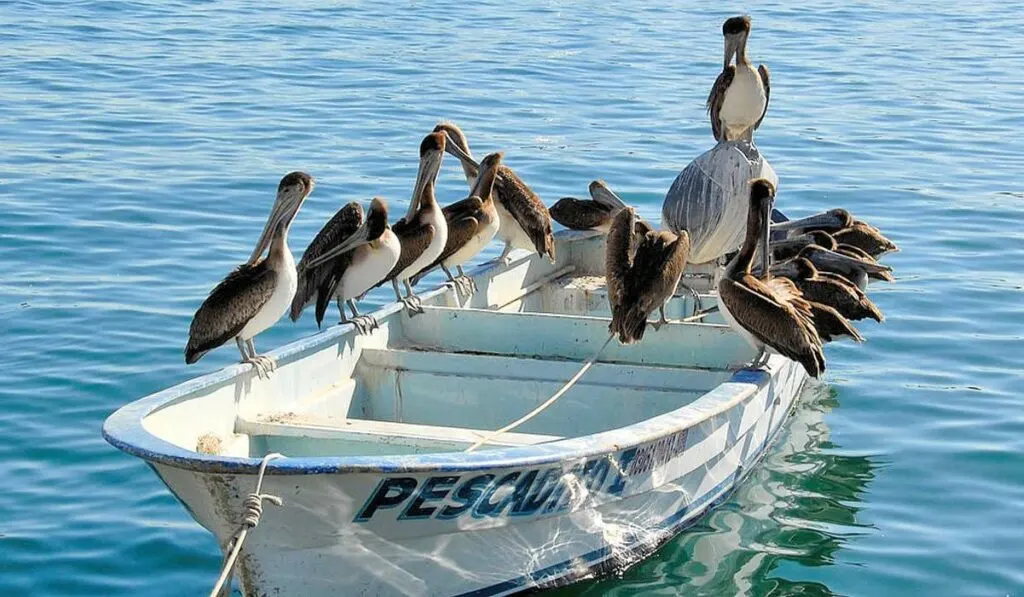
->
[236,413,562,446]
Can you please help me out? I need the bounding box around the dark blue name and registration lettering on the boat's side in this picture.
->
[354,429,687,522]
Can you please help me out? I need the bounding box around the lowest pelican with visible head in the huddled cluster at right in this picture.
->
[769,257,885,321]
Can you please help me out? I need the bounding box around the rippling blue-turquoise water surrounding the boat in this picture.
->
[0,0,1024,596]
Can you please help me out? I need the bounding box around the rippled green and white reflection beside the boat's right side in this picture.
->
[546,384,878,597]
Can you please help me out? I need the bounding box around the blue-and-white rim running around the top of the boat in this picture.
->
[102,234,783,475]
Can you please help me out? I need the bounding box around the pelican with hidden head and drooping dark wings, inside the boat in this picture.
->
[605,207,690,344]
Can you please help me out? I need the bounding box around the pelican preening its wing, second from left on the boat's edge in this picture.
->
[292,197,401,334]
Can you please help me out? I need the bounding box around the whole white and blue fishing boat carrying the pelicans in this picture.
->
[103,232,806,596]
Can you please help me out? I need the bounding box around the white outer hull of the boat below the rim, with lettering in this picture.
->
[154,356,806,597]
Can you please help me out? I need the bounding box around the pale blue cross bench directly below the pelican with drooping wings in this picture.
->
[398,307,754,369]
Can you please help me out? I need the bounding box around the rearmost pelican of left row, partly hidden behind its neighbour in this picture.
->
[434,122,555,263]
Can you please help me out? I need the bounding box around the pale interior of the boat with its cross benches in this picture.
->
[142,232,754,458]
